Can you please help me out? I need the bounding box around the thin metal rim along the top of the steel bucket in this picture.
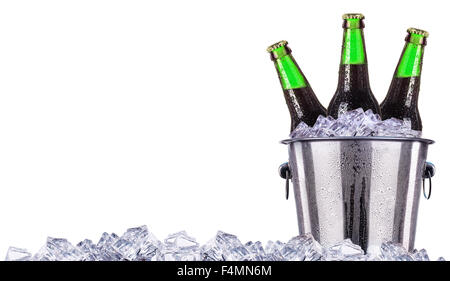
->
[280,137,435,144]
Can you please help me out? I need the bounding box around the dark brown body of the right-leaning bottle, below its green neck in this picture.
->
[381,76,422,131]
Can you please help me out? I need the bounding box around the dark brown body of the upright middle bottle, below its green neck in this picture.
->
[328,64,380,118]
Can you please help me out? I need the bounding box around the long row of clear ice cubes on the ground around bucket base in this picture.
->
[6,226,444,261]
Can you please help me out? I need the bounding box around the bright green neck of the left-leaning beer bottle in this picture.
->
[271,46,308,90]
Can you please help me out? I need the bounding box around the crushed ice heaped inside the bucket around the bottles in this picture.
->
[290,108,421,138]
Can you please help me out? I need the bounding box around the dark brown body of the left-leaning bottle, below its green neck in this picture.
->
[283,86,327,132]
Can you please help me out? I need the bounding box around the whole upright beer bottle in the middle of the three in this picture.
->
[328,14,380,118]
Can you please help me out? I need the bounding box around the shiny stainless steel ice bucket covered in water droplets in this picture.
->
[280,137,434,253]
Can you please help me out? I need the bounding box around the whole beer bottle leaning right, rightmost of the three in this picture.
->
[381,28,428,131]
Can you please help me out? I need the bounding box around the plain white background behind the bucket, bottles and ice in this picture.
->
[0,0,450,259]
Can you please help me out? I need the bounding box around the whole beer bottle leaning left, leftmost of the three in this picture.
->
[267,41,326,132]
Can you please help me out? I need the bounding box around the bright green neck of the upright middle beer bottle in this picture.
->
[341,19,367,64]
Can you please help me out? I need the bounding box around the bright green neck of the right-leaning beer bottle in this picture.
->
[395,34,425,78]
